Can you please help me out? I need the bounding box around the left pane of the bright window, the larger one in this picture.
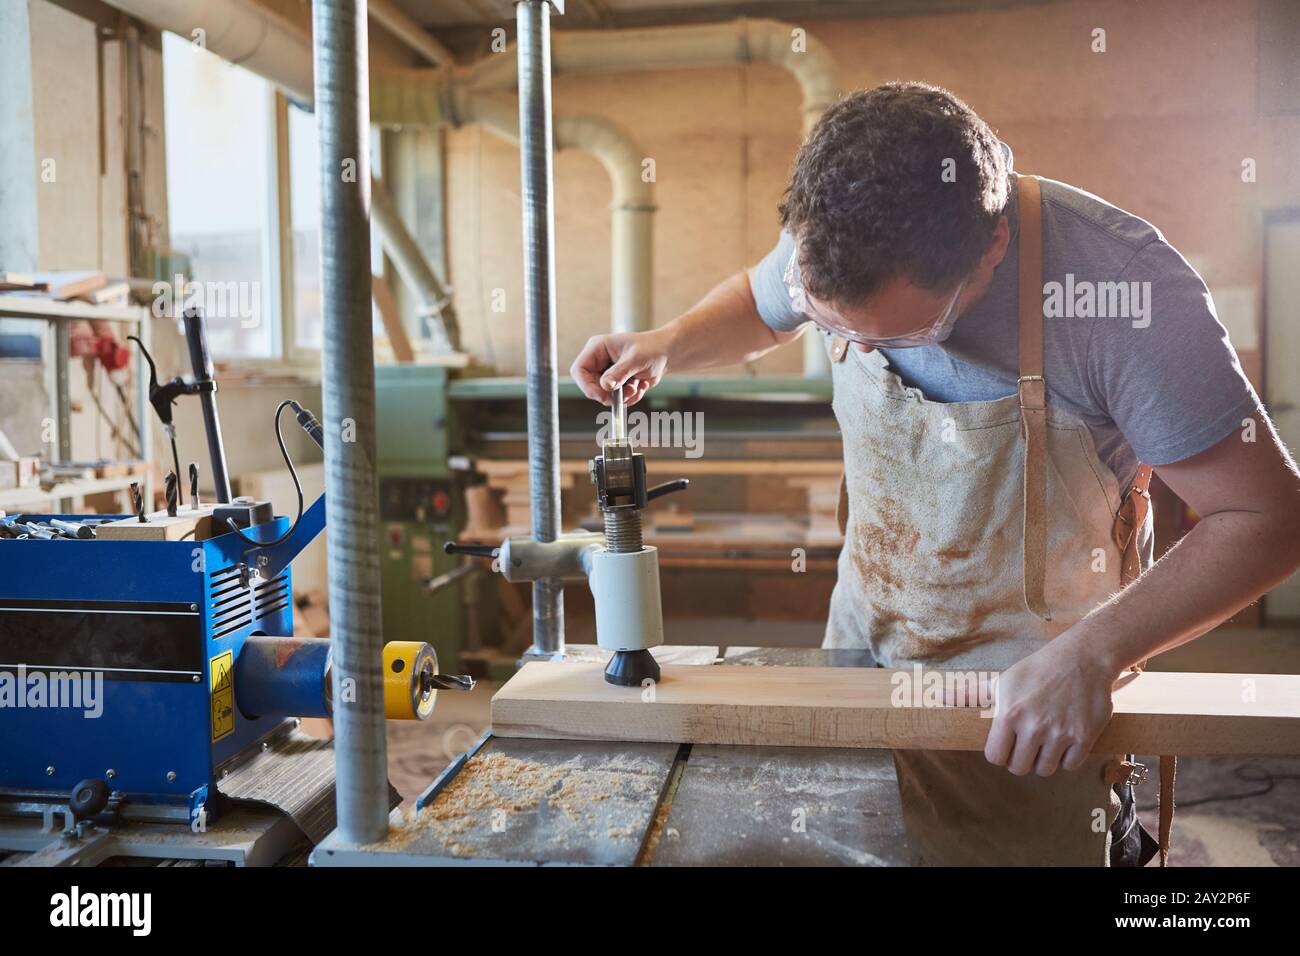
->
[163,33,280,358]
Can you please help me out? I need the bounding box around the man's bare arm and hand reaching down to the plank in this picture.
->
[984,411,1300,777]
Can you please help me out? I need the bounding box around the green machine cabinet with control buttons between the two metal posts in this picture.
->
[374,365,465,674]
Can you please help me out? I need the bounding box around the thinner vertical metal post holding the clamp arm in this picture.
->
[515,0,564,656]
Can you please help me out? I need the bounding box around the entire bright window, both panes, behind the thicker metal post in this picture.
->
[163,34,384,364]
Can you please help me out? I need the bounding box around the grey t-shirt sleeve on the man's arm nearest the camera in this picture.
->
[1086,239,1260,466]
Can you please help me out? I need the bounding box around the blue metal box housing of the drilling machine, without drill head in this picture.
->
[0,515,301,818]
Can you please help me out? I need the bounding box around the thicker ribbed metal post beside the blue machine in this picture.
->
[312,0,389,843]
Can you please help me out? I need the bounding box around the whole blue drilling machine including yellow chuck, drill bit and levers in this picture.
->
[0,317,462,865]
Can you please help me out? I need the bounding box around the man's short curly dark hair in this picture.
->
[779,83,1008,304]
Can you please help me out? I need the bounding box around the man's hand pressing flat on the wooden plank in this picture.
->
[984,631,1115,777]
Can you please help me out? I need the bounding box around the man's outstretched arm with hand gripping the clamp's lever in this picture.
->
[569,272,800,405]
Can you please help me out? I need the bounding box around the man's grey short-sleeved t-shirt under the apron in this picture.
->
[750,162,1260,483]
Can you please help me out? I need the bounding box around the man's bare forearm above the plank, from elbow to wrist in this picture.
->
[1062,511,1300,675]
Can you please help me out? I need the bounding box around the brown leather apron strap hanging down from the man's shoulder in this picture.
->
[1017,176,1052,620]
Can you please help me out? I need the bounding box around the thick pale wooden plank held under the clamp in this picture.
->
[491,661,1300,754]
